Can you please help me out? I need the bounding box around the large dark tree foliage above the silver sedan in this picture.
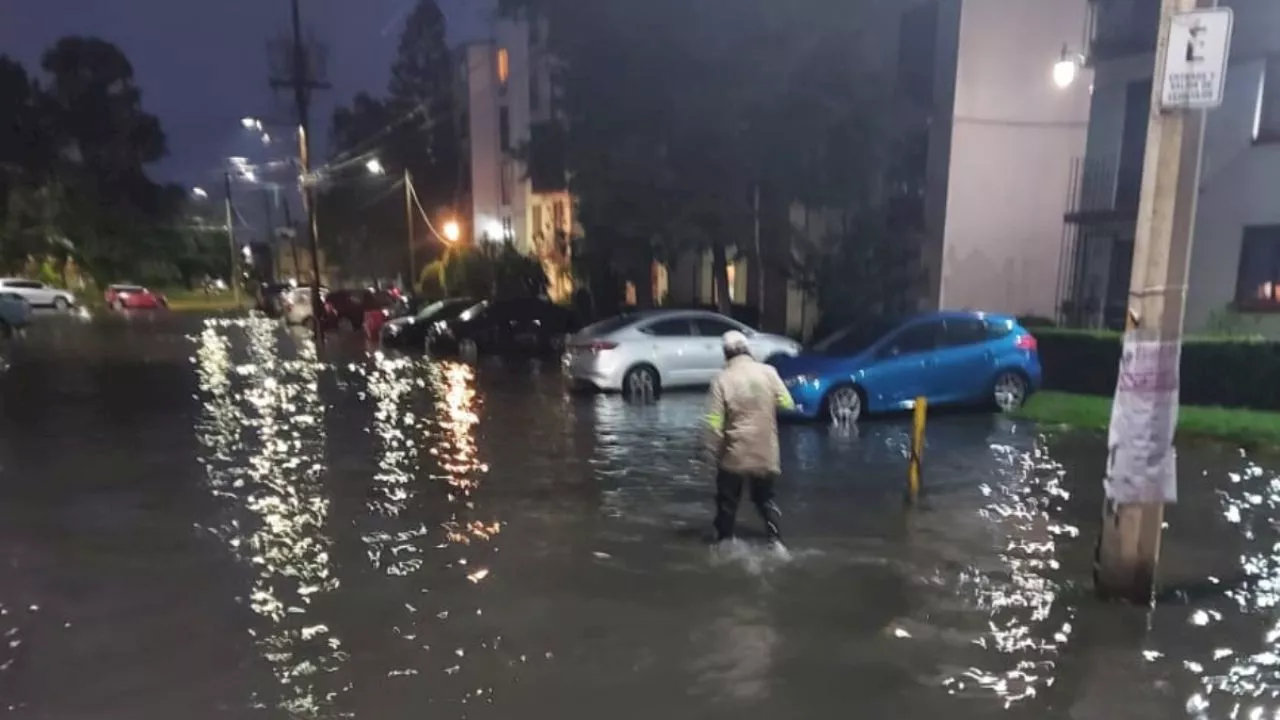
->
[500,0,913,325]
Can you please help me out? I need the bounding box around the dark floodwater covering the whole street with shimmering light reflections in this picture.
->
[0,318,1280,720]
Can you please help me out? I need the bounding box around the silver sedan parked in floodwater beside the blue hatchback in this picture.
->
[566,310,800,392]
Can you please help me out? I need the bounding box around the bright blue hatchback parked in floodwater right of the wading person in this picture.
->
[773,311,1041,421]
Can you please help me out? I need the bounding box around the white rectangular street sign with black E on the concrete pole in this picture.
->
[1160,8,1234,110]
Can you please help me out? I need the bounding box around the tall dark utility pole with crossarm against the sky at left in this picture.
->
[271,0,329,350]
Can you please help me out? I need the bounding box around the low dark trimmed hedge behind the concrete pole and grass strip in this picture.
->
[1032,328,1280,410]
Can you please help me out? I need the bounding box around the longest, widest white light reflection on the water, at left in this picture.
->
[196,320,349,717]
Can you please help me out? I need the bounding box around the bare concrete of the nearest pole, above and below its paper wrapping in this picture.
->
[1094,0,1213,605]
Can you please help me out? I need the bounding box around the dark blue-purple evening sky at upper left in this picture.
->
[0,0,489,190]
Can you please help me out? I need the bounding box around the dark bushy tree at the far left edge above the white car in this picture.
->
[0,37,194,283]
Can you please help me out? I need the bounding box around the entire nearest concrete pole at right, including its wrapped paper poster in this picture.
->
[1094,0,1225,605]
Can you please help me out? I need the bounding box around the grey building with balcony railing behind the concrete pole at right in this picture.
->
[1060,0,1280,337]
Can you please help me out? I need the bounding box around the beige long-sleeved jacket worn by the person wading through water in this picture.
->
[707,355,794,475]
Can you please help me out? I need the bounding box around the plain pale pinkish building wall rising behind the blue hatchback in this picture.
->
[916,0,1089,316]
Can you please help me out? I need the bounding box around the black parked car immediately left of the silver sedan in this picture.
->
[428,300,581,355]
